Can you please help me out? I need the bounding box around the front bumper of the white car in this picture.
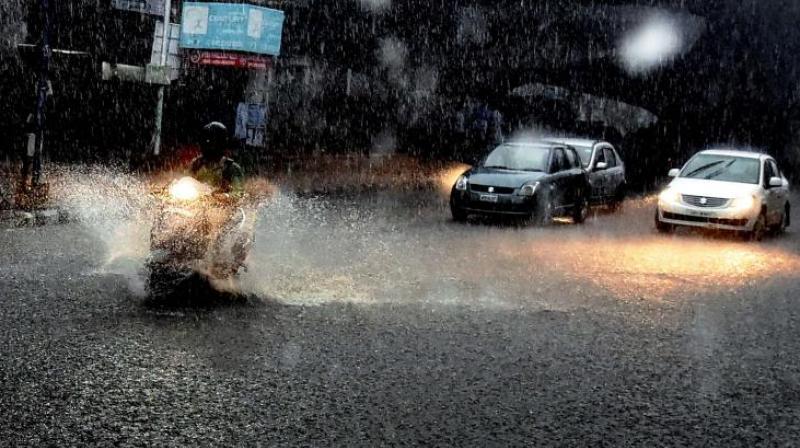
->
[657,202,758,231]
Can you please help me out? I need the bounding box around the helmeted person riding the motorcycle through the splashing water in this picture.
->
[190,121,255,273]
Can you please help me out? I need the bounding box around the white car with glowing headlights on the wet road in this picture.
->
[656,149,791,240]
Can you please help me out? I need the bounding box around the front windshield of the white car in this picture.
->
[680,154,761,184]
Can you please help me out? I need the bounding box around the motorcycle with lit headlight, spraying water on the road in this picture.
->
[147,177,252,298]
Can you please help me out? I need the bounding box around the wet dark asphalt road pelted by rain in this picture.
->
[0,189,800,446]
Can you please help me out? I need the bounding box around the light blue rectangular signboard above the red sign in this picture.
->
[181,2,284,56]
